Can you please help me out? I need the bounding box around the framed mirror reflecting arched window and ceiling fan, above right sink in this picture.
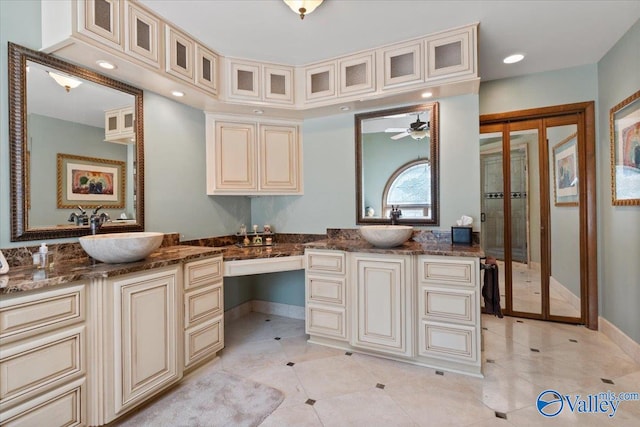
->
[355,102,439,225]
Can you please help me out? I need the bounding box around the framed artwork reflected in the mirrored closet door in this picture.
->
[553,133,578,206]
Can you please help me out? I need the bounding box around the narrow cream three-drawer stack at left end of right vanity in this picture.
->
[305,250,350,342]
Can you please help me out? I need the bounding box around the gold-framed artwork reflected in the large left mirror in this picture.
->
[57,153,126,209]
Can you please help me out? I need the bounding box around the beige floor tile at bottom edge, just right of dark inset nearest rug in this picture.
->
[314,387,417,427]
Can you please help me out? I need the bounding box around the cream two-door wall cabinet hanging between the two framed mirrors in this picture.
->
[206,113,303,195]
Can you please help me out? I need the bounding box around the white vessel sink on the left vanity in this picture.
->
[79,231,164,264]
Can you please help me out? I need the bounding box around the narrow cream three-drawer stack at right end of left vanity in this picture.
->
[183,256,224,369]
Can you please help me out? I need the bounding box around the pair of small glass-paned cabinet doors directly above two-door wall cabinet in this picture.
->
[227,58,294,104]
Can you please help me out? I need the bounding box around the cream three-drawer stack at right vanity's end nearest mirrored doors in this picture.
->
[418,256,481,370]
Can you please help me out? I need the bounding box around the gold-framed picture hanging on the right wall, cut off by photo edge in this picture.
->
[609,91,640,206]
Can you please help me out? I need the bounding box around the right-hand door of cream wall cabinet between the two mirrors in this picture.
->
[259,125,300,193]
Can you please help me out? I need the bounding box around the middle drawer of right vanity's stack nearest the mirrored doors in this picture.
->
[420,287,476,323]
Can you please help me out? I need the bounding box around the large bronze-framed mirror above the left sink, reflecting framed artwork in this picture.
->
[9,43,144,241]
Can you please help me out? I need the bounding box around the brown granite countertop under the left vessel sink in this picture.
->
[0,246,222,295]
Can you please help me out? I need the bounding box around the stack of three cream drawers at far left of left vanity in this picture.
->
[0,283,87,426]
